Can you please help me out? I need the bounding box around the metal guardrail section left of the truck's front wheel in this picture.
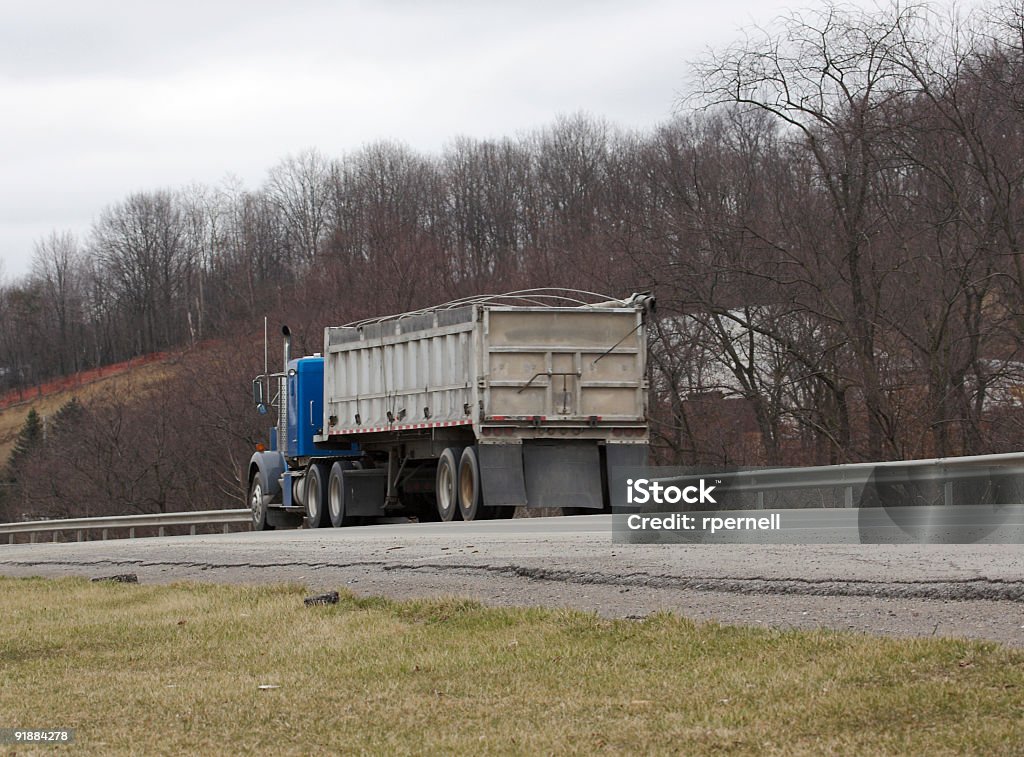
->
[0,508,252,544]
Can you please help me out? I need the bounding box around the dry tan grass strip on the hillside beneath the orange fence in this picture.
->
[0,359,175,468]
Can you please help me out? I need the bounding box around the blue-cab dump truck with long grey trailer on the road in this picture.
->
[245,290,654,530]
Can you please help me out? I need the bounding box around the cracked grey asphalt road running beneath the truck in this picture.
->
[0,515,1024,646]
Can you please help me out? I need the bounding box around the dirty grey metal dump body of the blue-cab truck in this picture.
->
[317,300,646,441]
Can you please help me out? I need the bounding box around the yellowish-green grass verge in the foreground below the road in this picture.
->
[0,579,1024,755]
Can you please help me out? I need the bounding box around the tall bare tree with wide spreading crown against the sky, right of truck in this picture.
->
[697,5,916,459]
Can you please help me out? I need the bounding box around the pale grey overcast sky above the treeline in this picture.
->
[0,0,933,279]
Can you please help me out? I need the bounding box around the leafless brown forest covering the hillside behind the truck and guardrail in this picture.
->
[0,0,1024,514]
